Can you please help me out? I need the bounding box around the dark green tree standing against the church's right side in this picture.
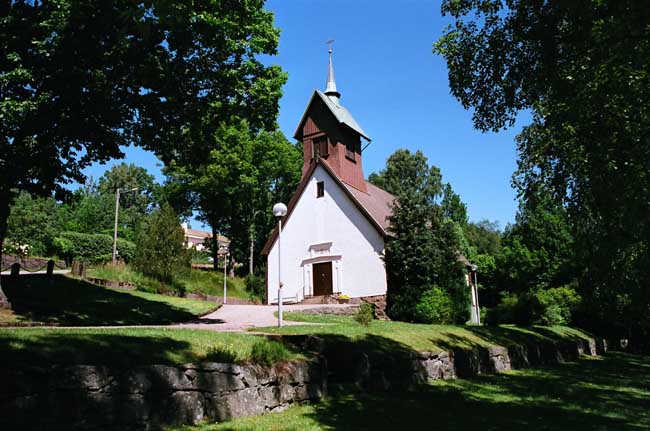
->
[369,150,462,321]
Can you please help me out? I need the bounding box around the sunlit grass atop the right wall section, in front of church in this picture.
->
[258,313,589,352]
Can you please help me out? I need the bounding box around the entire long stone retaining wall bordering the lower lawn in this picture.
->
[0,336,607,431]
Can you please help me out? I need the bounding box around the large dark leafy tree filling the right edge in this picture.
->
[435,0,650,343]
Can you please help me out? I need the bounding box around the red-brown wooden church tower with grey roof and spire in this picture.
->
[293,47,370,193]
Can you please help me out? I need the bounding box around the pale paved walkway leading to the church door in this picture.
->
[173,304,351,331]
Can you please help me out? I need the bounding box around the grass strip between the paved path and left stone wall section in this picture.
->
[0,328,303,366]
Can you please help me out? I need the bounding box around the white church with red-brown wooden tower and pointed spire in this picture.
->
[262,49,394,304]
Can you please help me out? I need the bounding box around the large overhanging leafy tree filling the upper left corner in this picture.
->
[0,0,286,306]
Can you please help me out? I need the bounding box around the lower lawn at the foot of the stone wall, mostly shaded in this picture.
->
[168,353,650,431]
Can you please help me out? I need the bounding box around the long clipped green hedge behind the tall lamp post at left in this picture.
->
[53,232,135,263]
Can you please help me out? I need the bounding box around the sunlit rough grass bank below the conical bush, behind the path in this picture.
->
[87,264,250,299]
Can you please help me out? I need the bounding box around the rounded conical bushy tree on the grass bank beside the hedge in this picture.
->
[134,204,191,282]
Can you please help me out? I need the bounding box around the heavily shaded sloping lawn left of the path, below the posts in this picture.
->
[0,275,216,326]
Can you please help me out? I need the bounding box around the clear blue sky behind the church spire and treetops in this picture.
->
[86,0,523,227]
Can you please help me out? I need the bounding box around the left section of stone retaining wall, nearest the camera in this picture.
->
[0,360,326,430]
